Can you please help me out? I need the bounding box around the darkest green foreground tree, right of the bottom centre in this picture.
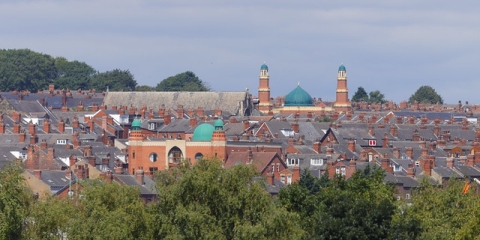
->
[279,168,395,239]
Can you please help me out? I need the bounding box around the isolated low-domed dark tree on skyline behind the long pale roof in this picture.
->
[156,71,210,92]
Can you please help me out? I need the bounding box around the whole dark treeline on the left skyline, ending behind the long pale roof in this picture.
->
[0,49,210,92]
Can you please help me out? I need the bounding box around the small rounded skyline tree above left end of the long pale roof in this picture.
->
[91,69,137,91]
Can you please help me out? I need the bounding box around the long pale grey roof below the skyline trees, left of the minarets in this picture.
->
[103,92,248,115]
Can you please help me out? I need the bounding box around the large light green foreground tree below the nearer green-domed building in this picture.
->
[151,160,302,239]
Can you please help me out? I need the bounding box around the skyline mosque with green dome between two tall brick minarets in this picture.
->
[258,63,352,115]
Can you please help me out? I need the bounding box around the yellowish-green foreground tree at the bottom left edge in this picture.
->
[0,164,32,239]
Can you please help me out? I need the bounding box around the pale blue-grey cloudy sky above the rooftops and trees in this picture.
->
[0,0,480,104]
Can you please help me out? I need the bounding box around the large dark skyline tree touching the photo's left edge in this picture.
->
[0,49,57,92]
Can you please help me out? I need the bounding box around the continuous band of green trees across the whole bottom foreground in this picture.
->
[0,160,480,239]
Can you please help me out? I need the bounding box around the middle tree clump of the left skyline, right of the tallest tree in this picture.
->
[54,57,96,89]
